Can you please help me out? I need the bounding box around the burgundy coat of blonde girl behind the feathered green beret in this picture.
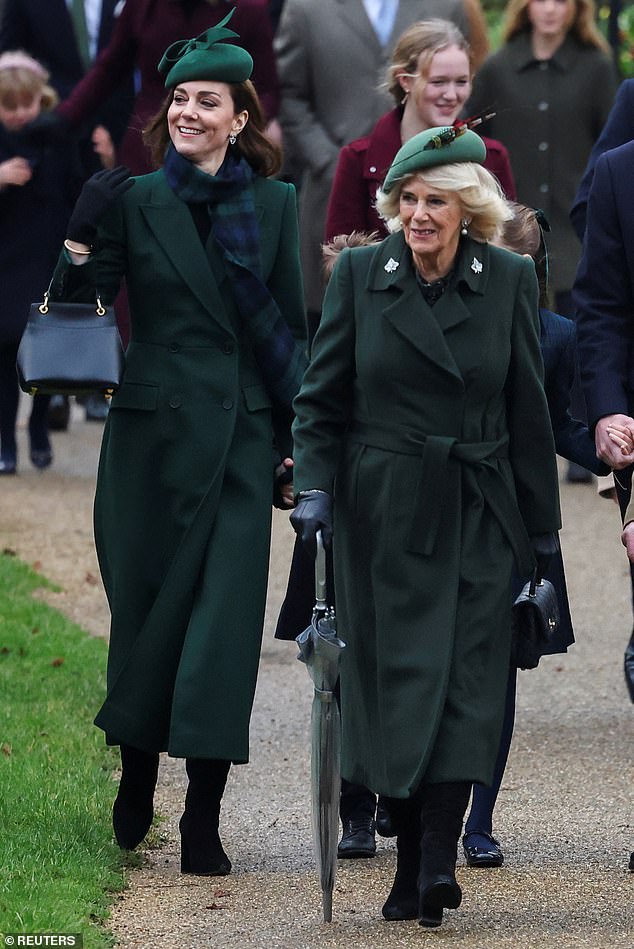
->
[325,108,516,241]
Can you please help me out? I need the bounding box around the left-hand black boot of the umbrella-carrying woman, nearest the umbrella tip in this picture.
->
[381,797,420,922]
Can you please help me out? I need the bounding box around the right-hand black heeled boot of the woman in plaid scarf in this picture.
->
[178,758,231,876]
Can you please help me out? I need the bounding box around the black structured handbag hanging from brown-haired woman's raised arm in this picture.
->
[17,287,123,395]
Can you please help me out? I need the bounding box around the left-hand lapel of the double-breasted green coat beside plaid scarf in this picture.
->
[140,175,233,335]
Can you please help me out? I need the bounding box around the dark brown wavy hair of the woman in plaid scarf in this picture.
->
[143,79,282,178]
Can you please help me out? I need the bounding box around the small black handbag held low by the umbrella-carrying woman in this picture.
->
[511,570,559,669]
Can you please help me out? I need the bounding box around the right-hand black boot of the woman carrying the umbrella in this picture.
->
[418,781,471,927]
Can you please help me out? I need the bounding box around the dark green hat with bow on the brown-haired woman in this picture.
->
[158,7,253,89]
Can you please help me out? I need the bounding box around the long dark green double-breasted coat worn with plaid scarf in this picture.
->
[54,171,305,762]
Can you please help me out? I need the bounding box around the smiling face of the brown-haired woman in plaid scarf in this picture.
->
[167,80,248,174]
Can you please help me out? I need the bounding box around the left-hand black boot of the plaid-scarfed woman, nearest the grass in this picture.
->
[112,745,159,850]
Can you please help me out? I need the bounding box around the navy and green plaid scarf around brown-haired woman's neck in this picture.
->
[163,145,307,408]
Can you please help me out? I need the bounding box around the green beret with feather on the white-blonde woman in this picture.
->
[382,125,487,194]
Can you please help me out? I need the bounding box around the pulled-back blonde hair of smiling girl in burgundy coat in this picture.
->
[385,18,473,105]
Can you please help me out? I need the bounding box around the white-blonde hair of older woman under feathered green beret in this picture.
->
[376,161,513,241]
